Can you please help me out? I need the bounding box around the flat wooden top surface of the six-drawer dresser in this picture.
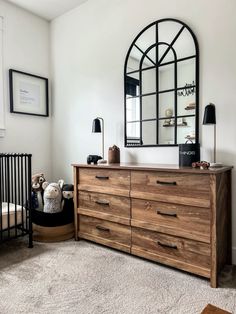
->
[72,163,233,174]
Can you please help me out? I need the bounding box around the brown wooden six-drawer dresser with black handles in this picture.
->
[73,164,232,287]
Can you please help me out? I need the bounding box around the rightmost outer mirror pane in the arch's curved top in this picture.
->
[173,28,196,59]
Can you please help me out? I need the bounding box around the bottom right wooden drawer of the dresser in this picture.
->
[131,227,210,277]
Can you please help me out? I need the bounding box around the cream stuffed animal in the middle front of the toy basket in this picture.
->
[43,180,64,214]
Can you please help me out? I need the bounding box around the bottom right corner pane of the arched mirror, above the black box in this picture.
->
[177,117,195,144]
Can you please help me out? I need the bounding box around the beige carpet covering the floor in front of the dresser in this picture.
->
[0,240,236,314]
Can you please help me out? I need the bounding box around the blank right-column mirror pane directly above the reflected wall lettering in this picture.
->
[177,58,196,87]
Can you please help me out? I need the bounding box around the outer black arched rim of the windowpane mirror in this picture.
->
[124,18,199,148]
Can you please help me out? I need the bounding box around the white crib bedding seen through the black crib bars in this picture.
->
[0,202,26,230]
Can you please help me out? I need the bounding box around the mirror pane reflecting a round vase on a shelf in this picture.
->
[159,92,175,120]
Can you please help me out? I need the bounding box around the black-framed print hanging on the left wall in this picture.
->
[9,69,49,117]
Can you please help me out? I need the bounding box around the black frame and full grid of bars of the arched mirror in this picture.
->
[124,18,200,148]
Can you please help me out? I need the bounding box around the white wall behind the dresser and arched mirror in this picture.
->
[51,0,236,262]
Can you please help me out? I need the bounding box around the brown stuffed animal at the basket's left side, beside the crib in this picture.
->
[32,173,45,211]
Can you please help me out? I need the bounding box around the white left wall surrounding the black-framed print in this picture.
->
[0,1,51,179]
